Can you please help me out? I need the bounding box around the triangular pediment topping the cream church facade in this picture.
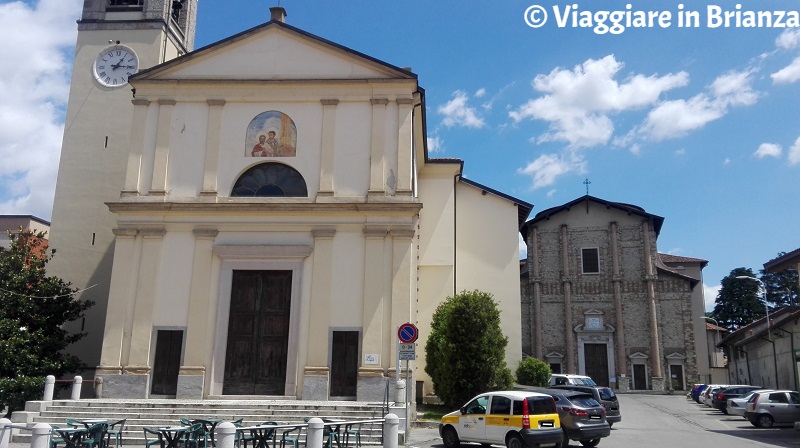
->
[131,21,416,84]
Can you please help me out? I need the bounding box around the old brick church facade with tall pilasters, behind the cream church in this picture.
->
[520,195,706,391]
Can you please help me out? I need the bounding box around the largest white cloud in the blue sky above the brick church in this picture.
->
[509,55,689,148]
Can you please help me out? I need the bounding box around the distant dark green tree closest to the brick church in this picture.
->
[712,268,766,328]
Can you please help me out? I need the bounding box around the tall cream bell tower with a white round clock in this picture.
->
[48,0,198,384]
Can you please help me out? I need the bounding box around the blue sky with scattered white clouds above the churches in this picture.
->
[0,0,800,309]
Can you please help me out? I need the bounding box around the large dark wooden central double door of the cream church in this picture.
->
[222,270,292,395]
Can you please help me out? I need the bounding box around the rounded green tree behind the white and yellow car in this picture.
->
[425,290,513,407]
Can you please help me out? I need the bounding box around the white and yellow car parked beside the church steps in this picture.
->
[439,390,564,448]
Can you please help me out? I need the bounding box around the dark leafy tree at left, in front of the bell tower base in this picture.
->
[0,230,93,413]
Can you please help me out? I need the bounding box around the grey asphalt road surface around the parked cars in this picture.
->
[408,394,800,448]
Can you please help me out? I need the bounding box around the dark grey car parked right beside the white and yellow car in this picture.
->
[536,388,611,447]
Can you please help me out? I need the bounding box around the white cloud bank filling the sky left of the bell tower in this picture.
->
[0,0,82,219]
